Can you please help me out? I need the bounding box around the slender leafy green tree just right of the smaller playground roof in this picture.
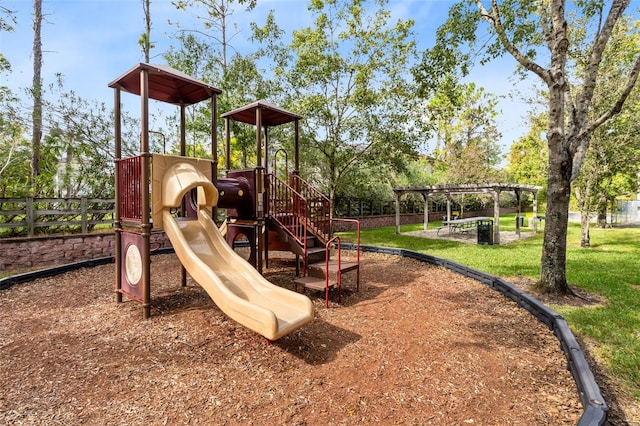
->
[274,0,420,205]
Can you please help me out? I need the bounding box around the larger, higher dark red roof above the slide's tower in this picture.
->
[109,62,222,105]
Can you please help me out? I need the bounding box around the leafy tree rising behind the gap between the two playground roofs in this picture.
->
[165,0,277,169]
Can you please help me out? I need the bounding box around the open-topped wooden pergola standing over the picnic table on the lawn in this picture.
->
[393,183,542,244]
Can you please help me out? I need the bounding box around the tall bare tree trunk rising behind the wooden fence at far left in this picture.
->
[31,0,42,195]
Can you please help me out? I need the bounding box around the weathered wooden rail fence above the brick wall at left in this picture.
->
[0,197,115,237]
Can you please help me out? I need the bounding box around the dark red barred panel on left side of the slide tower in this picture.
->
[118,155,142,222]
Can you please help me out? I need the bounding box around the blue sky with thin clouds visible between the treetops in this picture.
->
[0,0,540,153]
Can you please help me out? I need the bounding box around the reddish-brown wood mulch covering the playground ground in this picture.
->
[0,254,582,425]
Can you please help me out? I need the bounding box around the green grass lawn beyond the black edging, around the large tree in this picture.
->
[343,215,640,403]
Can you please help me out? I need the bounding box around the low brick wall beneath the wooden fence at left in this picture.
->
[0,232,171,273]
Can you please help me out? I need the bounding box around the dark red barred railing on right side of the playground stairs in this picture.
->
[289,174,331,243]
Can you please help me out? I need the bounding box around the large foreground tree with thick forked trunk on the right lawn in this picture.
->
[416,0,640,293]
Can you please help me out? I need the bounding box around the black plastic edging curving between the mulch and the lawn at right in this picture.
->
[342,243,608,426]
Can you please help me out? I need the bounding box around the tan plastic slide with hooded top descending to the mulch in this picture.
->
[162,158,314,340]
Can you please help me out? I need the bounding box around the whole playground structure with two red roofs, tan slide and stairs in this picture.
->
[109,63,360,340]
